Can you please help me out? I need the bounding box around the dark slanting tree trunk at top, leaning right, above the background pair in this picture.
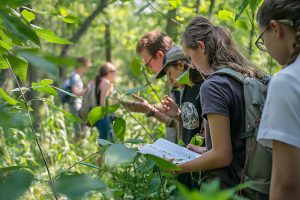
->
[59,0,109,79]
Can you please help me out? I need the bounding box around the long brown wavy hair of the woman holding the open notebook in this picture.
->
[182,16,263,78]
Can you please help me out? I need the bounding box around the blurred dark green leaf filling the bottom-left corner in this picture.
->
[0,168,33,200]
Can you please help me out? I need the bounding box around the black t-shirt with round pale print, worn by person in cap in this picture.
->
[180,81,203,145]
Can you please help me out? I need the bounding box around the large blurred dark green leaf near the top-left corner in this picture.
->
[2,14,40,45]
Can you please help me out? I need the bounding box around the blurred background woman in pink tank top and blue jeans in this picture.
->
[95,62,117,141]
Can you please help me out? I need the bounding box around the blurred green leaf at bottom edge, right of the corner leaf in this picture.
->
[54,174,106,199]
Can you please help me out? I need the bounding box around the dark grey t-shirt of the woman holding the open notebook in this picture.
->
[200,74,245,188]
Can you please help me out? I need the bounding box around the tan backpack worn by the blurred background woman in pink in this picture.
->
[79,83,97,124]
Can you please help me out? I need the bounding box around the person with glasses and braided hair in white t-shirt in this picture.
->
[255,0,300,200]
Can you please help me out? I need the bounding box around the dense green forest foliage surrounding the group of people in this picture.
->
[0,0,279,200]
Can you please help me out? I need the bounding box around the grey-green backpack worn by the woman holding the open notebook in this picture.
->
[213,68,272,200]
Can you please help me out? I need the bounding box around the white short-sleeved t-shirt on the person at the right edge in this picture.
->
[257,56,300,148]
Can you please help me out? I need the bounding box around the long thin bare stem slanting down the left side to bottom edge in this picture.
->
[6,58,58,200]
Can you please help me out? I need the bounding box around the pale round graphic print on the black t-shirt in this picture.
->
[181,102,199,129]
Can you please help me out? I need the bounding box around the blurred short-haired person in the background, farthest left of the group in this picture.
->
[68,57,92,141]
